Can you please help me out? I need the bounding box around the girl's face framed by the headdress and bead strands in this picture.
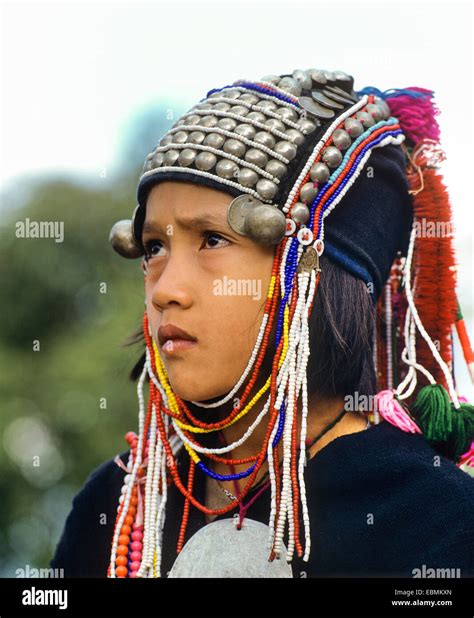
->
[142,181,274,401]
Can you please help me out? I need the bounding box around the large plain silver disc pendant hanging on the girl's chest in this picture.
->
[168,518,293,579]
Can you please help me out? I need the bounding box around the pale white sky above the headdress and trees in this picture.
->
[0,0,474,388]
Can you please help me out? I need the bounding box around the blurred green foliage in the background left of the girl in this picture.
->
[0,100,182,577]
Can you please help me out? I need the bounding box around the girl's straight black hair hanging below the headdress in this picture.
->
[124,255,376,396]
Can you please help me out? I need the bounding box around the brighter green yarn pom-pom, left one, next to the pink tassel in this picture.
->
[412,384,453,442]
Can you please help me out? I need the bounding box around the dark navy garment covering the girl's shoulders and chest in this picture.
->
[51,421,474,577]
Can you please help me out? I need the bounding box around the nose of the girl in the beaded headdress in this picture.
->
[151,253,192,311]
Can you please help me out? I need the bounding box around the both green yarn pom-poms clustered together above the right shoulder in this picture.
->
[412,384,474,461]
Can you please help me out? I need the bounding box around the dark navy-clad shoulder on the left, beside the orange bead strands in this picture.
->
[50,451,129,577]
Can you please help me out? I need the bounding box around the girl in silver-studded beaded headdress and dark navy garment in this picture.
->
[51,69,474,578]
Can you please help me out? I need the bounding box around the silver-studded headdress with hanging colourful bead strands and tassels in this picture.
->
[109,69,474,577]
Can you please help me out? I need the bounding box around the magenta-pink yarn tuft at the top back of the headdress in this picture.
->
[385,86,440,144]
